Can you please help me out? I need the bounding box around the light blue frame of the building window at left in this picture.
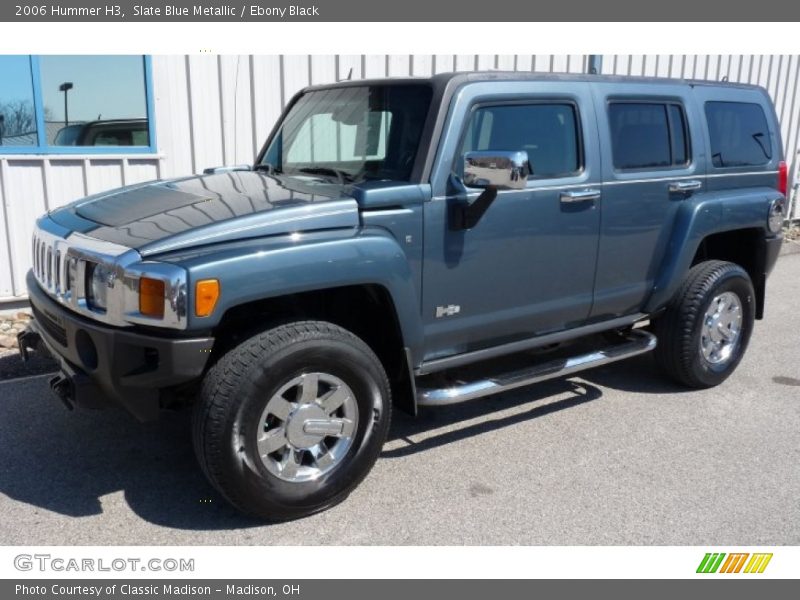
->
[0,54,158,156]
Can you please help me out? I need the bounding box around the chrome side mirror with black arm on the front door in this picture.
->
[450,150,532,231]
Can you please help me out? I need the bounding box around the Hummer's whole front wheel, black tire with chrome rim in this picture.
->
[194,321,391,521]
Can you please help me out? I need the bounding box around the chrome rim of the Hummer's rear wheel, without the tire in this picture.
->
[700,292,743,365]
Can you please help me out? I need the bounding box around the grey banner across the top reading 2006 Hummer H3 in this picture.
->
[0,0,800,21]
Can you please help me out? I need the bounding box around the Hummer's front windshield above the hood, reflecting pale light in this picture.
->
[262,84,431,183]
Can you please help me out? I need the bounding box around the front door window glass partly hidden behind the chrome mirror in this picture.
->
[461,104,582,178]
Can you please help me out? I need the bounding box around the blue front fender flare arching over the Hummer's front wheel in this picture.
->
[162,229,422,355]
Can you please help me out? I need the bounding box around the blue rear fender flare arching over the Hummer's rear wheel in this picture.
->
[644,188,781,313]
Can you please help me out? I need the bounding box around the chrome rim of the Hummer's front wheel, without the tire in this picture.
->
[256,373,358,483]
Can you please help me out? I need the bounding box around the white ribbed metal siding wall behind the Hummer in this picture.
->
[0,54,800,302]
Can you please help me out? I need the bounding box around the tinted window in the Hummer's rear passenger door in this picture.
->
[608,102,690,171]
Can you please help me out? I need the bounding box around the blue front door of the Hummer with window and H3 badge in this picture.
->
[422,82,601,361]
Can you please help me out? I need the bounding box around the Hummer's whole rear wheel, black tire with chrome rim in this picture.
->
[655,260,755,388]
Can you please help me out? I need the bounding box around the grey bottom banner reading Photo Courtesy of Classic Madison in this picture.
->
[0,577,797,600]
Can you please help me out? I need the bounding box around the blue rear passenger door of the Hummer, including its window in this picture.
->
[591,83,705,319]
